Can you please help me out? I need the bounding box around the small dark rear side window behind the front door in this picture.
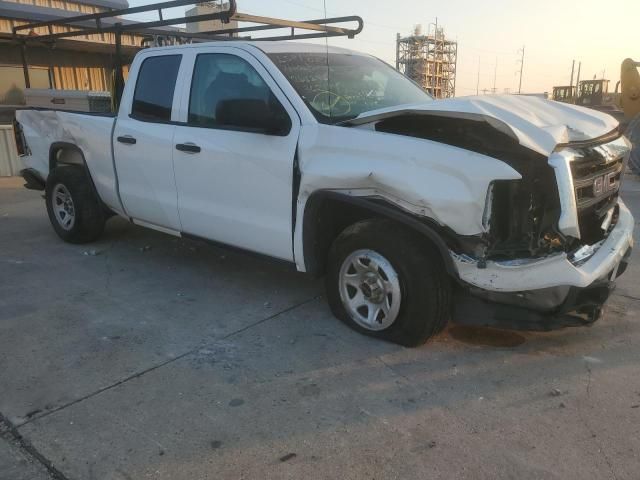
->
[131,55,182,122]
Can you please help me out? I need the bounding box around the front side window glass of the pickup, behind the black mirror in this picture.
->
[188,53,282,128]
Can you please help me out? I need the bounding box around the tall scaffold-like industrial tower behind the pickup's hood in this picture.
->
[396,22,458,98]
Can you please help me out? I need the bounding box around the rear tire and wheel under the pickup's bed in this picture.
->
[45,165,106,243]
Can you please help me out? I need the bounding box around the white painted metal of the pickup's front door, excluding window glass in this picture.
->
[173,44,300,261]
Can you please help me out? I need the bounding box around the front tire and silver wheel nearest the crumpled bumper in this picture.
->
[325,219,451,347]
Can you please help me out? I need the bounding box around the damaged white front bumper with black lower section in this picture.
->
[451,200,634,330]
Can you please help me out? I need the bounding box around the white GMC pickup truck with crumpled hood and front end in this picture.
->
[16,41,634,345]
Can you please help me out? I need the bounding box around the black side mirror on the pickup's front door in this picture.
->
[216,99,291,136]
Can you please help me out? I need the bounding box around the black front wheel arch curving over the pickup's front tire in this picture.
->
[302,190,457,277]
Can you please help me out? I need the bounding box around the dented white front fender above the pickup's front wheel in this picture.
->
[295,124,521,266]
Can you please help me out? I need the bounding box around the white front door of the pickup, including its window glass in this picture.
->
[174,46,300,260]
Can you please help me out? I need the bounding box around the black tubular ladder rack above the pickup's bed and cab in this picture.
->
[13,0,364,104]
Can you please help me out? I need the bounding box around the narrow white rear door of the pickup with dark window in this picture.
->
[113,53,182,231]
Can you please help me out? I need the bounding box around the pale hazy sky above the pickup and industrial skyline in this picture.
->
[129,0,640,96]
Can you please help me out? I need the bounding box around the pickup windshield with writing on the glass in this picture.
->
[269,52,433,123]
